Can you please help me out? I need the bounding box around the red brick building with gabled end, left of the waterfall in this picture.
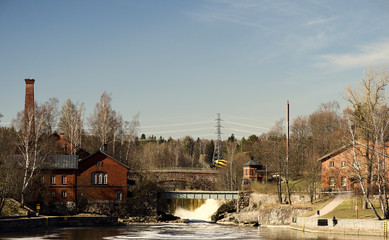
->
[39,151,128,210]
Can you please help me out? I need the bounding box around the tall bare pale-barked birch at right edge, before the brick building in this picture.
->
[346,69,389,219]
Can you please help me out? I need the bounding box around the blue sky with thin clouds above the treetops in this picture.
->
[0,0,389,139]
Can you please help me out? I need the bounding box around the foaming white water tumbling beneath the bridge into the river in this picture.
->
[174,199,221,221]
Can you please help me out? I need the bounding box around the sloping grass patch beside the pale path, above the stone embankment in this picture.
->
[322,198,381,219]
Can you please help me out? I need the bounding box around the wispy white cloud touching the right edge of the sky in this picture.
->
[317,40,389,69]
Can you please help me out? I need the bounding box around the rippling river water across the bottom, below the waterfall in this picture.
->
[0,222,382,240]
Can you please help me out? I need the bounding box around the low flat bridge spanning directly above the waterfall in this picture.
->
[159,191,239,200]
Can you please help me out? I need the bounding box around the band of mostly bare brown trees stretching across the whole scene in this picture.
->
[0,69,389,218]
